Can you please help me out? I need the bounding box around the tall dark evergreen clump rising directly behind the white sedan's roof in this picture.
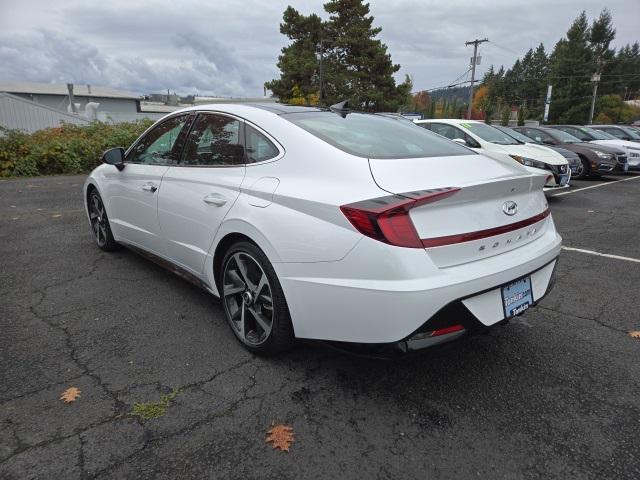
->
[266,0,412,111]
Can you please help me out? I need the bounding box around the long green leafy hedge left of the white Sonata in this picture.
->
[0,120,153,177]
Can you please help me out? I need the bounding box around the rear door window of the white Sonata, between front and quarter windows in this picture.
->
[180,113,244,167]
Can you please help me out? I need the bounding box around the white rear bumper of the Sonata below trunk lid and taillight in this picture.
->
[274,222,561,345]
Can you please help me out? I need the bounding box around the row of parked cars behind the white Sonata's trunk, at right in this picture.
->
[415,119,640,191]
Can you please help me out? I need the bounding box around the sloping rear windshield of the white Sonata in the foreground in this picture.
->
[282,112,475,158]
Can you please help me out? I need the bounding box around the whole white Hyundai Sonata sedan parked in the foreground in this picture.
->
[84,104,561,354]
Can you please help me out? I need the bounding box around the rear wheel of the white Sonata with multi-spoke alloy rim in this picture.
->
[218,241,295,355]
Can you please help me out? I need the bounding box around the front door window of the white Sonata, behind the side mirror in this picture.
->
[127,115,189,165]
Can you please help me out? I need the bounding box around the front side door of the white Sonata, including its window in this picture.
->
[105,114,189,255]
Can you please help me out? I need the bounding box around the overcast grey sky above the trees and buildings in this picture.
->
[0,0,640,96]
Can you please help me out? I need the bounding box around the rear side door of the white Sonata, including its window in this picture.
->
[158,113,245,274]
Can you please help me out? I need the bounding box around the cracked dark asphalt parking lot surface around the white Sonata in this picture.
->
[0,176,640,480]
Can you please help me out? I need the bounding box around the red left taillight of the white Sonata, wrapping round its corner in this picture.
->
[340,187,460,248]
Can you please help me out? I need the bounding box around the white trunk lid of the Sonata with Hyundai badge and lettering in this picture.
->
[369,155,549,267]
